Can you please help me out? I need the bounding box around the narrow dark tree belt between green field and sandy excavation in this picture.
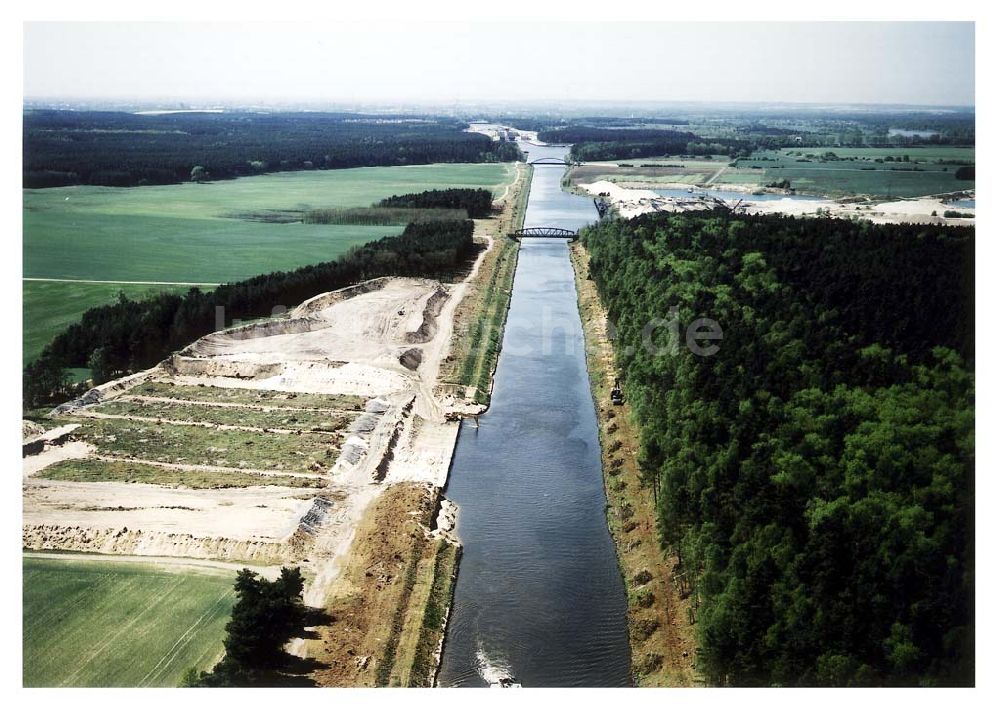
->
[23,220,475,408]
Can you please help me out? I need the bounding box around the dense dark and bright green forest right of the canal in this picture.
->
[582,212,974,685]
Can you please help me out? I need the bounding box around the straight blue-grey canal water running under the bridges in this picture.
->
[438,145,630,687]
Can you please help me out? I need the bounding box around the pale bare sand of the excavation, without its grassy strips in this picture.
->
[23,221,500,580]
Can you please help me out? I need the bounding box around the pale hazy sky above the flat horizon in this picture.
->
[24,22,975,105]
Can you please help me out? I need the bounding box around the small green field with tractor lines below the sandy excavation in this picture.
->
[22,557,234,687]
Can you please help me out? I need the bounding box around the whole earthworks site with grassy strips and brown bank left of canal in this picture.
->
[23,164,527,686]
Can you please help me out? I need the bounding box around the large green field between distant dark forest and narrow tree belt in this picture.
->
[23,164,513,360]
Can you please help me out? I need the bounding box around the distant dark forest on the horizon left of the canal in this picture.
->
[23,110,520,188]
